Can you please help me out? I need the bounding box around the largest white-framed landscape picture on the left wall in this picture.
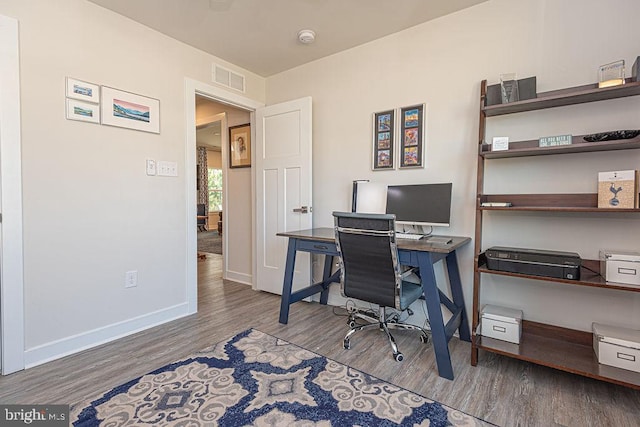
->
[100,86,160,133]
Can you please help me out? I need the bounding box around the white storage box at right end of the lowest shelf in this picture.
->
[593,323,640,372]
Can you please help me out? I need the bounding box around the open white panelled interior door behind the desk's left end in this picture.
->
[254,97,313,294]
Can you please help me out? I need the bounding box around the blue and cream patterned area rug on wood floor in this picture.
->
[71,329,493,427]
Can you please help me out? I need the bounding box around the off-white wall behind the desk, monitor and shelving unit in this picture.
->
[267,0,640,330]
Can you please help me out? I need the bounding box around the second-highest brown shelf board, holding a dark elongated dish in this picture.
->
[480,135,640,159]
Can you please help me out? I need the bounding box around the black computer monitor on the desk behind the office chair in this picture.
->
[386,183,452,227]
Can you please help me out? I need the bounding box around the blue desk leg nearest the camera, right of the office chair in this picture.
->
[418,252,453,380]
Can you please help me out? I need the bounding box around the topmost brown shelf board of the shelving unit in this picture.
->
[481,79,640,117]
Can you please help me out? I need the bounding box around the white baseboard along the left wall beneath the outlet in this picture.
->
[24,302,189,369]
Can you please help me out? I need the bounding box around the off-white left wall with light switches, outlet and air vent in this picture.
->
[0,0,264,365]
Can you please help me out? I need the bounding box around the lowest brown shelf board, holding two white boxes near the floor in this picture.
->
[473,320,640,389]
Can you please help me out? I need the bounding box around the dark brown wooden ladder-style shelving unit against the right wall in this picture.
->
[471,80,640,389]
